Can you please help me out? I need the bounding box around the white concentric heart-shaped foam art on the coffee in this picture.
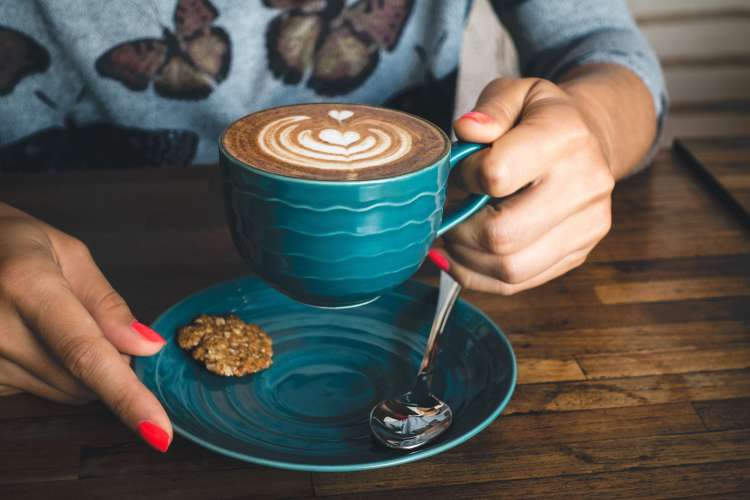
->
[258,110,412,170]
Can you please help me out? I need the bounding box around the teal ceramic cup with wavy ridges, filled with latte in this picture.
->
[219,104,489,307]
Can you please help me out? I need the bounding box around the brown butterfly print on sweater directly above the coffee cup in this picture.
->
[263,0,414,96]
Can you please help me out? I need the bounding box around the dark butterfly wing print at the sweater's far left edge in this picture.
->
[0,26,50,96]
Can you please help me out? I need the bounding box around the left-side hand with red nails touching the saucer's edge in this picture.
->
[0,203,172,451]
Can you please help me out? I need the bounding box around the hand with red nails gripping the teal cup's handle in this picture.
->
[438,64,655,295]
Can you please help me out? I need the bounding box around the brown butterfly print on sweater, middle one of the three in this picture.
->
[95,0,232,100]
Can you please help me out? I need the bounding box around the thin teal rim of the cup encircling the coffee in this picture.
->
[219,102,452,186]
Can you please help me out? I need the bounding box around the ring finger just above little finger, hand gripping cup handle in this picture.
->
[447,203,610,284]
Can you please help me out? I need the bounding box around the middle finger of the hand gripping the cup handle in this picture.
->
[445,162,614,255]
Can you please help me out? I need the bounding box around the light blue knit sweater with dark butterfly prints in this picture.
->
[0,0,666,173]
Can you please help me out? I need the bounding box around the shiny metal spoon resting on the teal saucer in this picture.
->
[370,271,461,450]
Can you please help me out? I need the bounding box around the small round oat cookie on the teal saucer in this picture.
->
[177,314,273,377]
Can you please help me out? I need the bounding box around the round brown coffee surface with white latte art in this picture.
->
[222,104,450,181]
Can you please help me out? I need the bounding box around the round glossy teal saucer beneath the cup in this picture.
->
[134,278,516,472]
